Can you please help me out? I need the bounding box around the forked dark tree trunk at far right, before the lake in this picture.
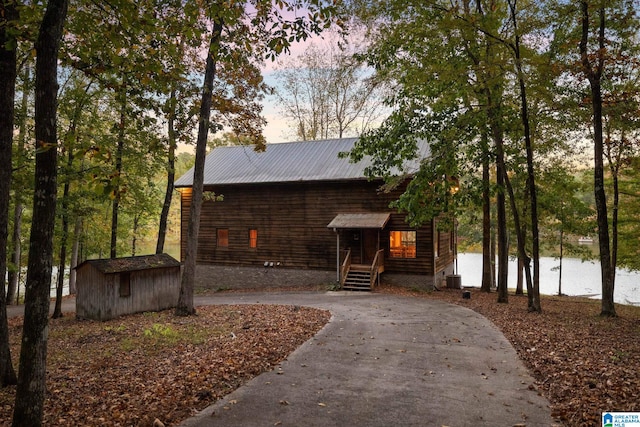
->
[580,1,616,317]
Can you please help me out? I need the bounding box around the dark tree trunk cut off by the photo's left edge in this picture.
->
[0,1,19,387]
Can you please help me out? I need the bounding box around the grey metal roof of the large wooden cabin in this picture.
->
[175,138,428,187]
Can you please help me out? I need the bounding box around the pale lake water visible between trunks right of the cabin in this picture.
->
[458,253,640,306]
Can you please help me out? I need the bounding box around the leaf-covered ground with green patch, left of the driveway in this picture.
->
[0,305,330,426]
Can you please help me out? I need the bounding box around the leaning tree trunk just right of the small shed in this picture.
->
[176,18,223,316]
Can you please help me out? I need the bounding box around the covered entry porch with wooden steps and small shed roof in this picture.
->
[327,213,391,290]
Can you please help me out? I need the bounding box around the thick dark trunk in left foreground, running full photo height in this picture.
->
[13,0,68,427]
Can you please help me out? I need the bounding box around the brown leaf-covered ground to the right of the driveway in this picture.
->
[380,287,640,427]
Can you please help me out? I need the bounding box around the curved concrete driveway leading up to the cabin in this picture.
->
[181,292,556,427]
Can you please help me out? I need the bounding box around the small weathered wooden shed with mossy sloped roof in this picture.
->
[76,254,180,320]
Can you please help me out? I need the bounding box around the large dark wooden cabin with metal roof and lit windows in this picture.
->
[175,138,456,288]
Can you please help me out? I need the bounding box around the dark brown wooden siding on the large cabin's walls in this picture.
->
[182,180,440,274]
